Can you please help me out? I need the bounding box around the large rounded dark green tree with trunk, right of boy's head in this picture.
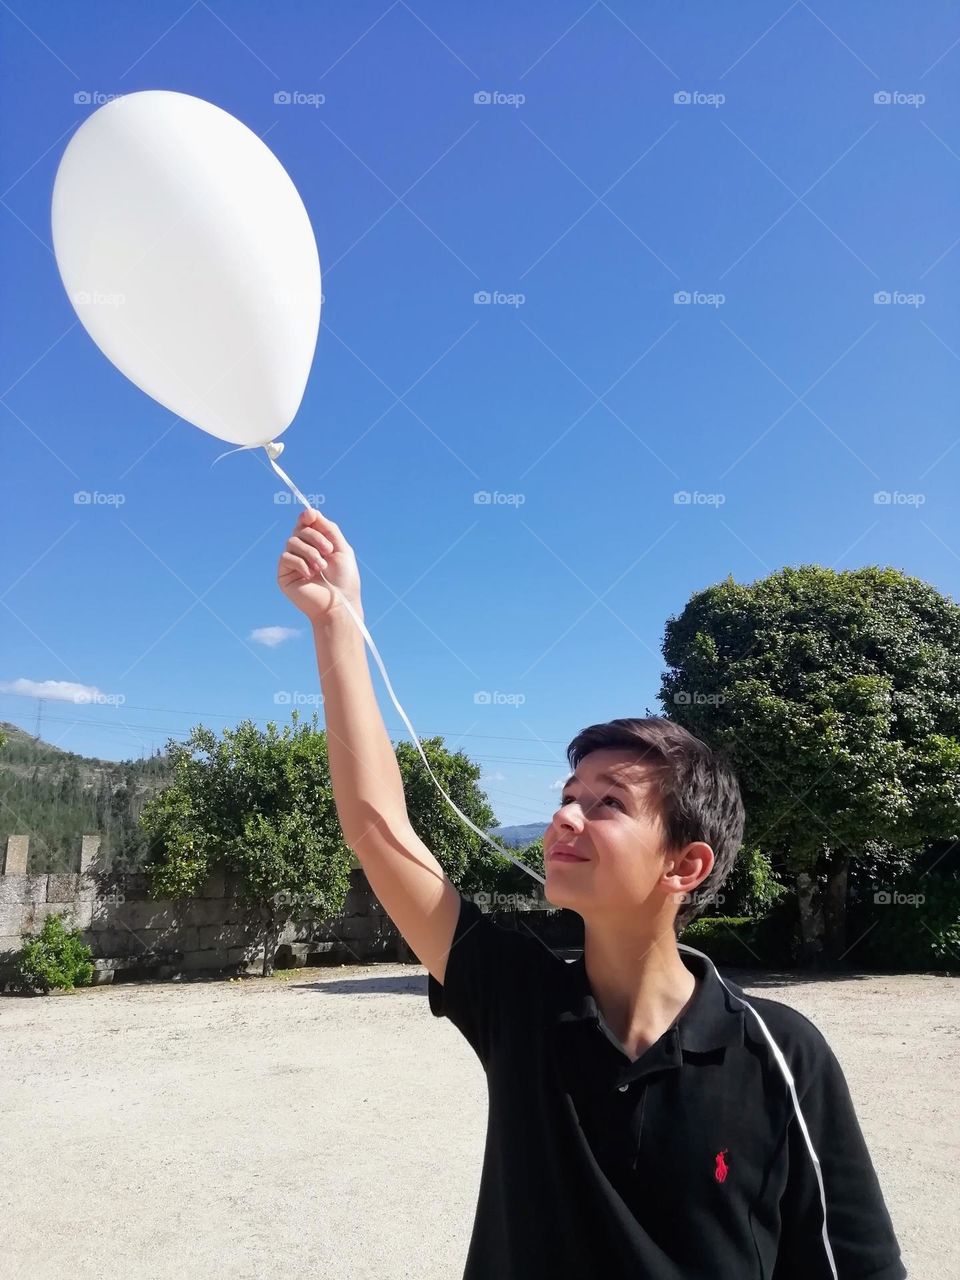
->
[659,564,960,960]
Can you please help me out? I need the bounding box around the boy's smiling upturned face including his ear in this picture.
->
[543,749,713,922]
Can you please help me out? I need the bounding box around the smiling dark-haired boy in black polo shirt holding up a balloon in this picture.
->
[278,511,906,1280]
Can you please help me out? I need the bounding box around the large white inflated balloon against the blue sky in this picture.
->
[51,90,320,445]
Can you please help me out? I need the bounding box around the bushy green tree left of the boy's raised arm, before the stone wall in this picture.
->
[141,709,349,975]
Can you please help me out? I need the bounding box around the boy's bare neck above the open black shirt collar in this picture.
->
[584,920,696,1059]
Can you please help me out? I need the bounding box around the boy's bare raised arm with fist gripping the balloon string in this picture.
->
[276,509,461,983]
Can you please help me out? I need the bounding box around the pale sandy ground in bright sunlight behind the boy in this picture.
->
[0,965,960,1280]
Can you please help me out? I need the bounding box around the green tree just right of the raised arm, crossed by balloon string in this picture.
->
[396,736,511,893]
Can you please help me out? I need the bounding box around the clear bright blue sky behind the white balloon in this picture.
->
[0,0,960,823]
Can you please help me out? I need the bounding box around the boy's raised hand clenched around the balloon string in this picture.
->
[276,508,364,621]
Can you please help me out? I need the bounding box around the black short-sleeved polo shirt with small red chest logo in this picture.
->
[428,896,906,1280]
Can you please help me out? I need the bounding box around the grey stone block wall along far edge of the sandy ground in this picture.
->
[0,835,582,991]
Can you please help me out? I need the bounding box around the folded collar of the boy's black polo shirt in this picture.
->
[554,945,744,1053]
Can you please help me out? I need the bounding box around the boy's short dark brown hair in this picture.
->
[567,717,744,936]
